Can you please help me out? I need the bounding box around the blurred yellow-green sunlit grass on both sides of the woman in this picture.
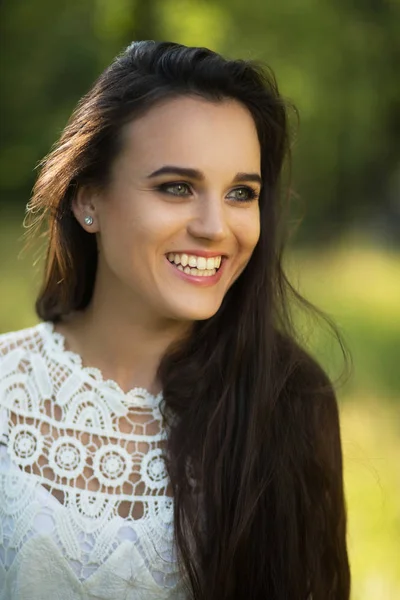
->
[0,219,400,600]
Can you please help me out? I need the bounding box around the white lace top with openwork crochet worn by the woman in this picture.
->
[0,322,189,600]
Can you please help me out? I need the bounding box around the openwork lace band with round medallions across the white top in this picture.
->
[8,403,172,520]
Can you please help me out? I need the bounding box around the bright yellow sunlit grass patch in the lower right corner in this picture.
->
[341,396,400,600]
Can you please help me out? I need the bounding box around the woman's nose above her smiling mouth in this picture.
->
[187,195,228,242]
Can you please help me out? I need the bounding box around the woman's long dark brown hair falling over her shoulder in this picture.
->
[28,42,350,600]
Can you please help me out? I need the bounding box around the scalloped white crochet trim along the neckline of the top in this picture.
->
[42,321,163,407]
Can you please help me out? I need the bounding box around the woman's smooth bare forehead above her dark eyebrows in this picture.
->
[119,96,260,174]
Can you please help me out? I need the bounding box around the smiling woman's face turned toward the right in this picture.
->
[81,97,261,321]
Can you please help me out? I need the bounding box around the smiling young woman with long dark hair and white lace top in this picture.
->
[0,42,350,600]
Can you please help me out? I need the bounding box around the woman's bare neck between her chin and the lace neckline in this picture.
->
[56,276,190,395]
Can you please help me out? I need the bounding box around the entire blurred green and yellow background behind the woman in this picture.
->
[0,0,400,600]
